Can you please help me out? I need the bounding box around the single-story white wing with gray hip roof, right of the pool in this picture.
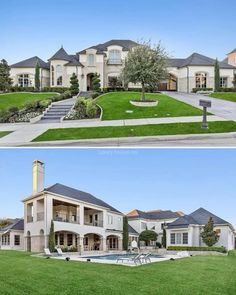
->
[166,208,235,250]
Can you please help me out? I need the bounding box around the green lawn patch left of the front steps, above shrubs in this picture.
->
[0,92,57,110]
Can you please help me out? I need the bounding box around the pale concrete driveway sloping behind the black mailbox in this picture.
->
[165,92,236,121]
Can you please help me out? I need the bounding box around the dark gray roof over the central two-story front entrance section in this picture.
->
[79,40,137,54]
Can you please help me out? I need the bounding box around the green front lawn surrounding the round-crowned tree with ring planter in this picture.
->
[97,92,202,120]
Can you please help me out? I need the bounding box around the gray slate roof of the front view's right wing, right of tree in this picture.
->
[168,53,235,69]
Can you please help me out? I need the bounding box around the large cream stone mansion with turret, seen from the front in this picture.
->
[11,40,236,92]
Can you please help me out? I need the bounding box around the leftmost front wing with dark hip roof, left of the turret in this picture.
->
[11,56,50,88]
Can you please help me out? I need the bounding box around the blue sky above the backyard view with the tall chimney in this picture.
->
[0,149,236,226]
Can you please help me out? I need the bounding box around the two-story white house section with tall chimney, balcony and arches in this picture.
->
[23,161,123,252]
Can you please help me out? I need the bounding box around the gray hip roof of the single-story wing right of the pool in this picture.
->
[168,208,230,228]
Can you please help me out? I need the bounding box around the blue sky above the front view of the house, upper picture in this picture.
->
[0,0,236,64]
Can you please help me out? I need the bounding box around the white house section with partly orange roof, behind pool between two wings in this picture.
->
[127,209,184,243]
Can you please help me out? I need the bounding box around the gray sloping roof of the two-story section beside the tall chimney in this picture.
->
[44,183,122,214]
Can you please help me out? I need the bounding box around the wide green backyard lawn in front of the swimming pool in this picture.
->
[0,250,236,295]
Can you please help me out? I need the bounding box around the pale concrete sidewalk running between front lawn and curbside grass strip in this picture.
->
[0,116,225,146]
